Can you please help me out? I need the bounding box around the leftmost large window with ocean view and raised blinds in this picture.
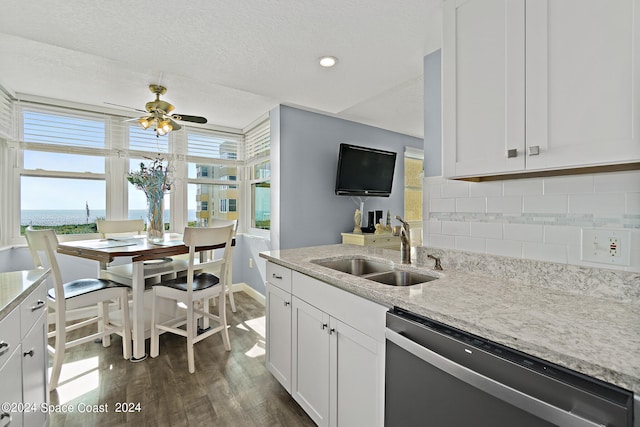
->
[19,108,106,235]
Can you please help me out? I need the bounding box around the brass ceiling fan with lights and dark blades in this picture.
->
[106,84,207,136]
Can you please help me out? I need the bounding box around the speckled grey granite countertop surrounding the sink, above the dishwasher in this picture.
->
[260,245,640,393]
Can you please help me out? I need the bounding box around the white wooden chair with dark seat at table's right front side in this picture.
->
[151,224,234,373]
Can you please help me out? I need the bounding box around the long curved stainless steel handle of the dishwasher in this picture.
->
[385,328,606,427]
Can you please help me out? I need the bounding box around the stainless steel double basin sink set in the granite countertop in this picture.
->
[311,258,437,286]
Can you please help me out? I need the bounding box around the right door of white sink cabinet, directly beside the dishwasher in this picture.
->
[330,319,384,427]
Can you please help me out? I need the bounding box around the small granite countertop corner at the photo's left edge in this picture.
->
[0,268,50,320]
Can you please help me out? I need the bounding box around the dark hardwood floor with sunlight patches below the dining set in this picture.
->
[50,292,315,426]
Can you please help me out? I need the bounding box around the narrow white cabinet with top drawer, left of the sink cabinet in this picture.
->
[266,263,291,393]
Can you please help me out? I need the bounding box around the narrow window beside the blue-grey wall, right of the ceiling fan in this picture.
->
[245,119,271,230]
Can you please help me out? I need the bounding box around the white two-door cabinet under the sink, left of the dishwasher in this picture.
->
[291,272,387,426]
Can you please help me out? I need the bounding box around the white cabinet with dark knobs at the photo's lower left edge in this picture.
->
[0,283,49,427]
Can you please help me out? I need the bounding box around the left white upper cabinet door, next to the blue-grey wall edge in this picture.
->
[442,0,525,177]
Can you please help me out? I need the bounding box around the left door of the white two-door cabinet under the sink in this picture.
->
[291,296,330,426]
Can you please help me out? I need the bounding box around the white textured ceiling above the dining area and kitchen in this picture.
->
[0,0,441,137]
